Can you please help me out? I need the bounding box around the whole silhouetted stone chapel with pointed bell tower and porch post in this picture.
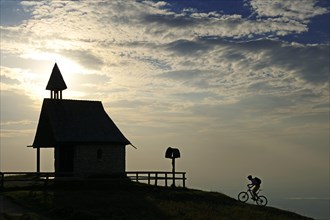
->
[32,63,130,177]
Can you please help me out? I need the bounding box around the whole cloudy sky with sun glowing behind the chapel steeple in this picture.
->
[0,0,330,218]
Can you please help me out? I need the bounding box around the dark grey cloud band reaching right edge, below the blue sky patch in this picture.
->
[201,38,330,84]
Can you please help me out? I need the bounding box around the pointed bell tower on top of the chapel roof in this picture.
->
[46,63,67,99]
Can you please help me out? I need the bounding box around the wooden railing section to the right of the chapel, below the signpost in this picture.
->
[126,171,187,187]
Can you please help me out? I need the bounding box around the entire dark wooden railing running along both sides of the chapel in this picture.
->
[0,171,187,189]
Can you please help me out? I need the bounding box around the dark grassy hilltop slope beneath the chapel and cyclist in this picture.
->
[0,182,310,220]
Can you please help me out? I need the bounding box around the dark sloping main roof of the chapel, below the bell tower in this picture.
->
[32,99,130,148]
